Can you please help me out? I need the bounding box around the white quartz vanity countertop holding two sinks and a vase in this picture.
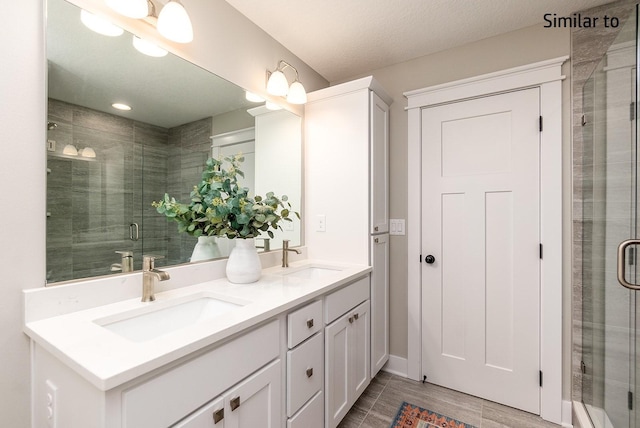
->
[25,260,371,391]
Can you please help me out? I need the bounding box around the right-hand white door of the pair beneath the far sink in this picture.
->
[349,300,371,398]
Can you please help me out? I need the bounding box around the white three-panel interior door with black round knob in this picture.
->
[422,88,540,413]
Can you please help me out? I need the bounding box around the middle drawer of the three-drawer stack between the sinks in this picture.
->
[287,332,324,416]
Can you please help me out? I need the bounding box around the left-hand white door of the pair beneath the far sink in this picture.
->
[324,313,353,428]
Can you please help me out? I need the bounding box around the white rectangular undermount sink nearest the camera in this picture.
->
[95,296,243,342]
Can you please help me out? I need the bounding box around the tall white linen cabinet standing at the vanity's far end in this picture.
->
[304,77,392,424]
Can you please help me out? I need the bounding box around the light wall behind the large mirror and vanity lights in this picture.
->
[0,0,327,428]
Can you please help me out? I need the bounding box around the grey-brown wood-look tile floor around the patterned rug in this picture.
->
[339,372,559,428]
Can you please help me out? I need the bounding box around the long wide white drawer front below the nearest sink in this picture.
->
[122,320,280,428]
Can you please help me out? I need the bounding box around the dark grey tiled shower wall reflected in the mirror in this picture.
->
[47,99,212,282]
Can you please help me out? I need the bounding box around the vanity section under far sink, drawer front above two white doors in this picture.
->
[325,277,371,428]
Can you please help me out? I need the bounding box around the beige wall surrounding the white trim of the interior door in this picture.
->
[338,25,571,399]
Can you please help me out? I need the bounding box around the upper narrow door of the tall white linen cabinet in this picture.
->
[369,91,389,234]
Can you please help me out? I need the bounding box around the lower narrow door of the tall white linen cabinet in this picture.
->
[371,234,389,377]
